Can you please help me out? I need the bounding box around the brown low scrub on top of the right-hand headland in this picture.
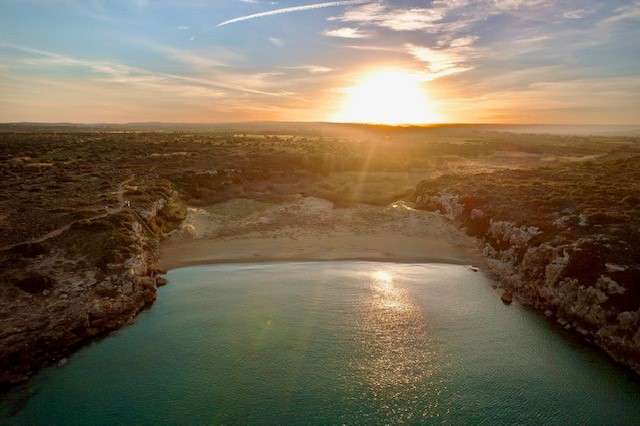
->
[417,153,640,292]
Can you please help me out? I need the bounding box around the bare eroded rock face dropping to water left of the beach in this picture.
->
[0,218,162,385]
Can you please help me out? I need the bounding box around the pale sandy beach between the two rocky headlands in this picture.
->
[159,197,479,269]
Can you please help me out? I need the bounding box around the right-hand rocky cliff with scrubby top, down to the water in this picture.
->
[414,158,640,373]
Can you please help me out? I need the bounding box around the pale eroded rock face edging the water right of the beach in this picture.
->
[419,188,640,373]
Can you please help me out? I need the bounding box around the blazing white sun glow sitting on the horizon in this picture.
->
[331,70,441,125]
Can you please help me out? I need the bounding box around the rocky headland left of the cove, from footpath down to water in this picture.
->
[0,199,174,386]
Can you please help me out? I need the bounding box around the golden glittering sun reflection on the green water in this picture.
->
[354,270,446,421]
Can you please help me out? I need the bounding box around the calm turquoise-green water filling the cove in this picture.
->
[0,262,640,425]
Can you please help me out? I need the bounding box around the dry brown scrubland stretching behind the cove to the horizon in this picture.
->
[0,125,640,382]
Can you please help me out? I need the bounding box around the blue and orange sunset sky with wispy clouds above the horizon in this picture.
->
[0,0,640,124]
